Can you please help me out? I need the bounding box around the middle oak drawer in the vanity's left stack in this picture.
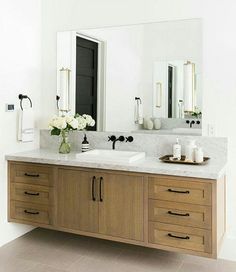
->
[11,183,53,205]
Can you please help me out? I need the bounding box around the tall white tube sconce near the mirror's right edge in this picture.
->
[184,61,195,112]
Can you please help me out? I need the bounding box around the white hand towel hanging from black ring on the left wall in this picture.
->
[18,108,34,142]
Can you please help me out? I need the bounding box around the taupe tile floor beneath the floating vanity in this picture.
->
[0,229,236,272]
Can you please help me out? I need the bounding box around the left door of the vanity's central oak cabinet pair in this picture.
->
[57,169,99,232]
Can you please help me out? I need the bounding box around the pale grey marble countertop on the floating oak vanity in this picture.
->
[6,149,226,179]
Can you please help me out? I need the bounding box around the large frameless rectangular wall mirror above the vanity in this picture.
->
[57,19,202,133]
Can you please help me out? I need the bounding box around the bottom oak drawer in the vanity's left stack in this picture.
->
[10,201,50,225]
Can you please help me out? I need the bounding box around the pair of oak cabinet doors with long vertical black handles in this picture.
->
[56,168,143,241]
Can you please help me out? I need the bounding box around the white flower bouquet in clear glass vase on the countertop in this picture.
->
[49,114,95,154]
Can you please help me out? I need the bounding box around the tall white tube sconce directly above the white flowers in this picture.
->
[57,68,71,112]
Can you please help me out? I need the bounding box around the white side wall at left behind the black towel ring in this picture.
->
[0,0,41,245]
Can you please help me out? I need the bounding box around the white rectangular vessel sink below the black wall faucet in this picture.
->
[76,149,145,163]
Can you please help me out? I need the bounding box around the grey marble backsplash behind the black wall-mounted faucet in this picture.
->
[40,130,228,162]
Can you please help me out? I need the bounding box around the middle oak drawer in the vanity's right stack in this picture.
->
[148,199,211,229]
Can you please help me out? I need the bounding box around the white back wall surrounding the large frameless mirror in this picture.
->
[41,0,236,260]
